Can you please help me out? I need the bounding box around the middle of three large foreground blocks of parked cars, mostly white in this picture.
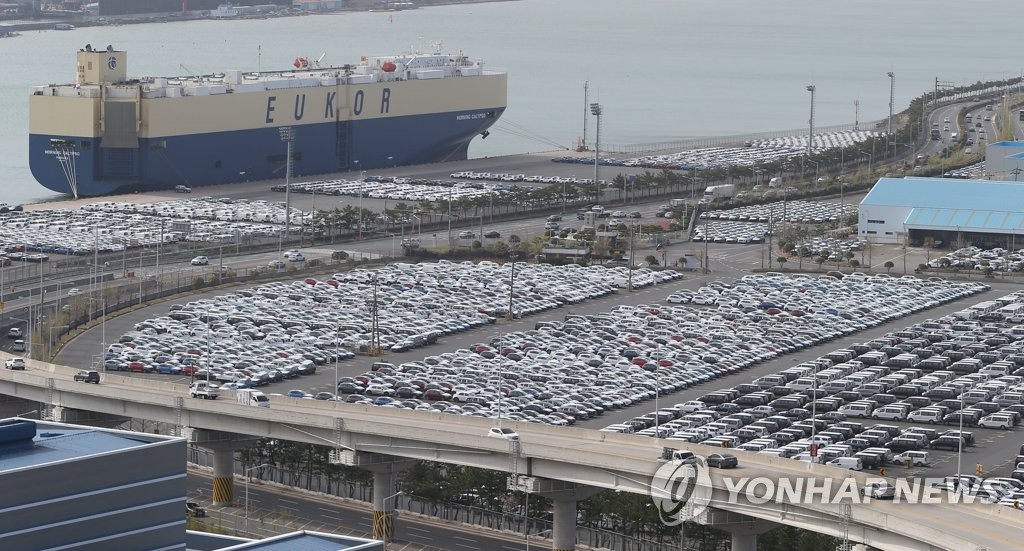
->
[278,274,983,425]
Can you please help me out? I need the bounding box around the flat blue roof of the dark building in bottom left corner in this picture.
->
[0,422,159,472]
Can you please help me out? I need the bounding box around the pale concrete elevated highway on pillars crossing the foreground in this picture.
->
[0,354,1024,551]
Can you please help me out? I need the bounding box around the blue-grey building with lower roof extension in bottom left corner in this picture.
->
[0,418,384,551]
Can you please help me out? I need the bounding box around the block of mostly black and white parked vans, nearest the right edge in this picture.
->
[604,292,1024,505]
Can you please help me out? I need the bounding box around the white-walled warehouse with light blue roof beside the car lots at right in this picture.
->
[857,178,1024,249]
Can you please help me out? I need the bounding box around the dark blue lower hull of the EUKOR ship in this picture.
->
[29,107,505,197]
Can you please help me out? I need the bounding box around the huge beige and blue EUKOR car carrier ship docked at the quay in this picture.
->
[29,45,508,198]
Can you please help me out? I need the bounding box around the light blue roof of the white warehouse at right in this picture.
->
[860,178,1024,208]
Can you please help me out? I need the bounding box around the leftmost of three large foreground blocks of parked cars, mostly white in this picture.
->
[103,260,667,376]
